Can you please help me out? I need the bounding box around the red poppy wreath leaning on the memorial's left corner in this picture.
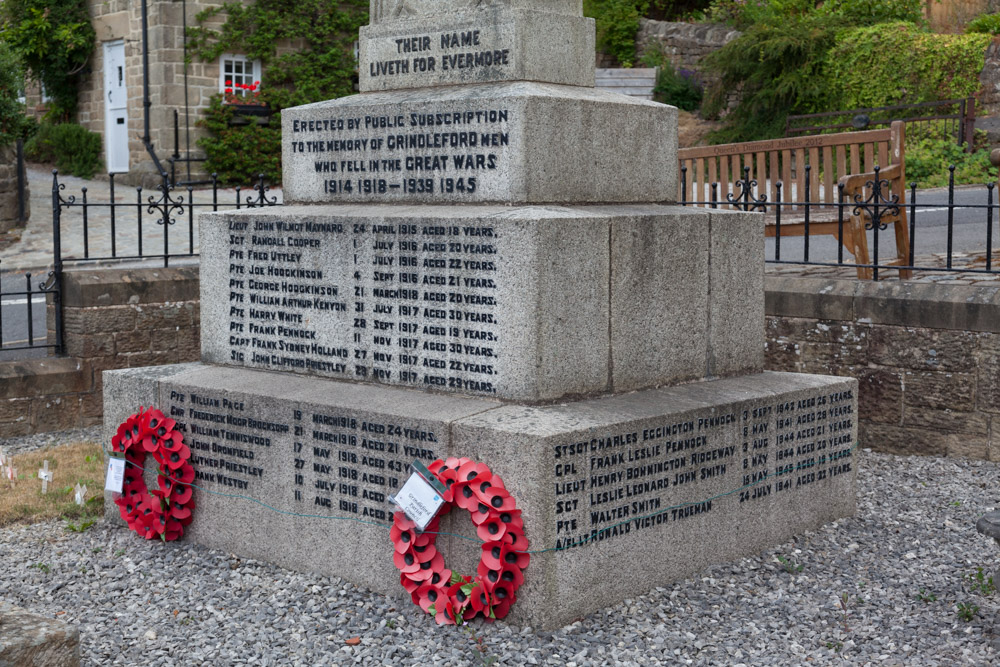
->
[111,407,194,542]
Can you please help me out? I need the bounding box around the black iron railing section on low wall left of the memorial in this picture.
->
[52,171,280,266]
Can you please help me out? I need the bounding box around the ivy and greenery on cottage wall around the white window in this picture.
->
[188,0,369,183]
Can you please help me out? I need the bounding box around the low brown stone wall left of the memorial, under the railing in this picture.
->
[0,268,201,438]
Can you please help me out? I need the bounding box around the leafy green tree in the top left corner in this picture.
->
[0,0,96,119]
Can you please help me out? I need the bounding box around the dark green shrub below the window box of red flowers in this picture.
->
[198,95,281,185]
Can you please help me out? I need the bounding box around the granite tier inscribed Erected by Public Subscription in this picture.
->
[281,81,677,204]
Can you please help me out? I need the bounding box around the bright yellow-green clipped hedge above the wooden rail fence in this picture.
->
[824,23,990,110]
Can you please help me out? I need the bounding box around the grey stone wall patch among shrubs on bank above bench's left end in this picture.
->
[636,19,740,92]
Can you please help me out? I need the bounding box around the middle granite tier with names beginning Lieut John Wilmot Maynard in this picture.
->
[201,204,764,402]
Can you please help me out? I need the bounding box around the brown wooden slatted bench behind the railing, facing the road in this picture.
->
[678,121,912,279]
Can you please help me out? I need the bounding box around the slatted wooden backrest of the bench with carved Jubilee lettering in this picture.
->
[678,121,905,215]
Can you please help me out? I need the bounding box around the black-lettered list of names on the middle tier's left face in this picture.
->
[228,220,503,395]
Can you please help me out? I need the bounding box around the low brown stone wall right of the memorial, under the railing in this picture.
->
[766,277,1000,460]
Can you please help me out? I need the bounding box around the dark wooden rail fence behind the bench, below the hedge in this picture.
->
[785,97,976,150]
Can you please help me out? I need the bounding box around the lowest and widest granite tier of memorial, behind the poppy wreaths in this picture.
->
[104,364,857,628]
